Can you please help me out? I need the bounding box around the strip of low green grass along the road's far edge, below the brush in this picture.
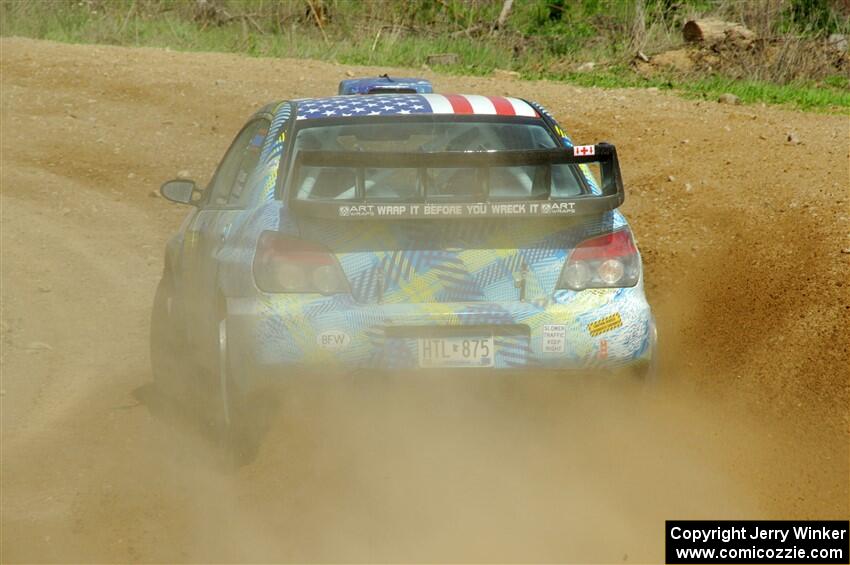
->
[0,0,850,112]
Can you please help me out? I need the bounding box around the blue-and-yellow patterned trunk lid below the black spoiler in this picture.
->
[299,218,589,303]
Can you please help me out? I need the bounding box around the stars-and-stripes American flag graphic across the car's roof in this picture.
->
[297,94,540,120]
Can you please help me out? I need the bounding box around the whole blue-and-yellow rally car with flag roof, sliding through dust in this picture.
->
[151,89,656,440]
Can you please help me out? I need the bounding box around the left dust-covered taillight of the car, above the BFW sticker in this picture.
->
[254,231,350,294]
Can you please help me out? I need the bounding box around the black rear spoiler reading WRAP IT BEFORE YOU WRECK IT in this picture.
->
[291,143,625,219]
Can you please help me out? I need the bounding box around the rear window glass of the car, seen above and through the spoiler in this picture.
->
[284,121,582,201]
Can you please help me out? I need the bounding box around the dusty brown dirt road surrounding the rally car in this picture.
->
[0,39,850,562]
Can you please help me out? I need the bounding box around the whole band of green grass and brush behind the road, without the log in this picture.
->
[0,0,850,111]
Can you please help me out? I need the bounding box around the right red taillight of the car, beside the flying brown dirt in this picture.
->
[558,229,640,290]
